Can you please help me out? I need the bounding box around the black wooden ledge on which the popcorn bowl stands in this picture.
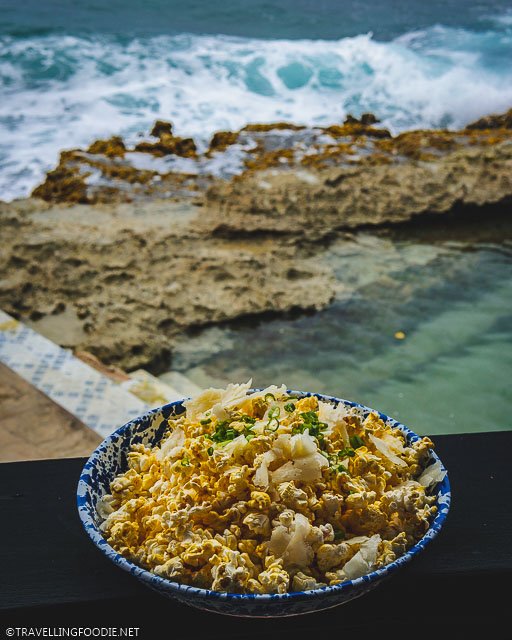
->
[0,432,512,640]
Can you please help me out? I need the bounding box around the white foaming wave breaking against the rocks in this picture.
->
[0,20,512,200]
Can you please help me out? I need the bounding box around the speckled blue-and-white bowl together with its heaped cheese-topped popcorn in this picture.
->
[77,381,450,617]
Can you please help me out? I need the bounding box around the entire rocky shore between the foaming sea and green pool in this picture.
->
[0,110,512,372]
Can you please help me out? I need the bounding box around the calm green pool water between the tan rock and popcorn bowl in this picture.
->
[172,224,512,434]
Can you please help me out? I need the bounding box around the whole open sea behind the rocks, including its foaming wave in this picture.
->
[0,0,512,200]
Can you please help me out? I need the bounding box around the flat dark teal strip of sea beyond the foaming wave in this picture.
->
[0,0,510,40]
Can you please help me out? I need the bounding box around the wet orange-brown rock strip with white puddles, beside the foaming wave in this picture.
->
[29,112,512,203]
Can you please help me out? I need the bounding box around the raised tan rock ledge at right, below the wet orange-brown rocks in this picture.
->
[208,141,512,237]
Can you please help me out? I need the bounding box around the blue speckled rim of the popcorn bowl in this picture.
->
[77,388,451,603]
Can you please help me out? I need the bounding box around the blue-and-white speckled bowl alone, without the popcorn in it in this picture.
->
[77,391,450,617]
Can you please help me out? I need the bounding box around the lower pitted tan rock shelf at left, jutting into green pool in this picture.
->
[0,201,336,371]
